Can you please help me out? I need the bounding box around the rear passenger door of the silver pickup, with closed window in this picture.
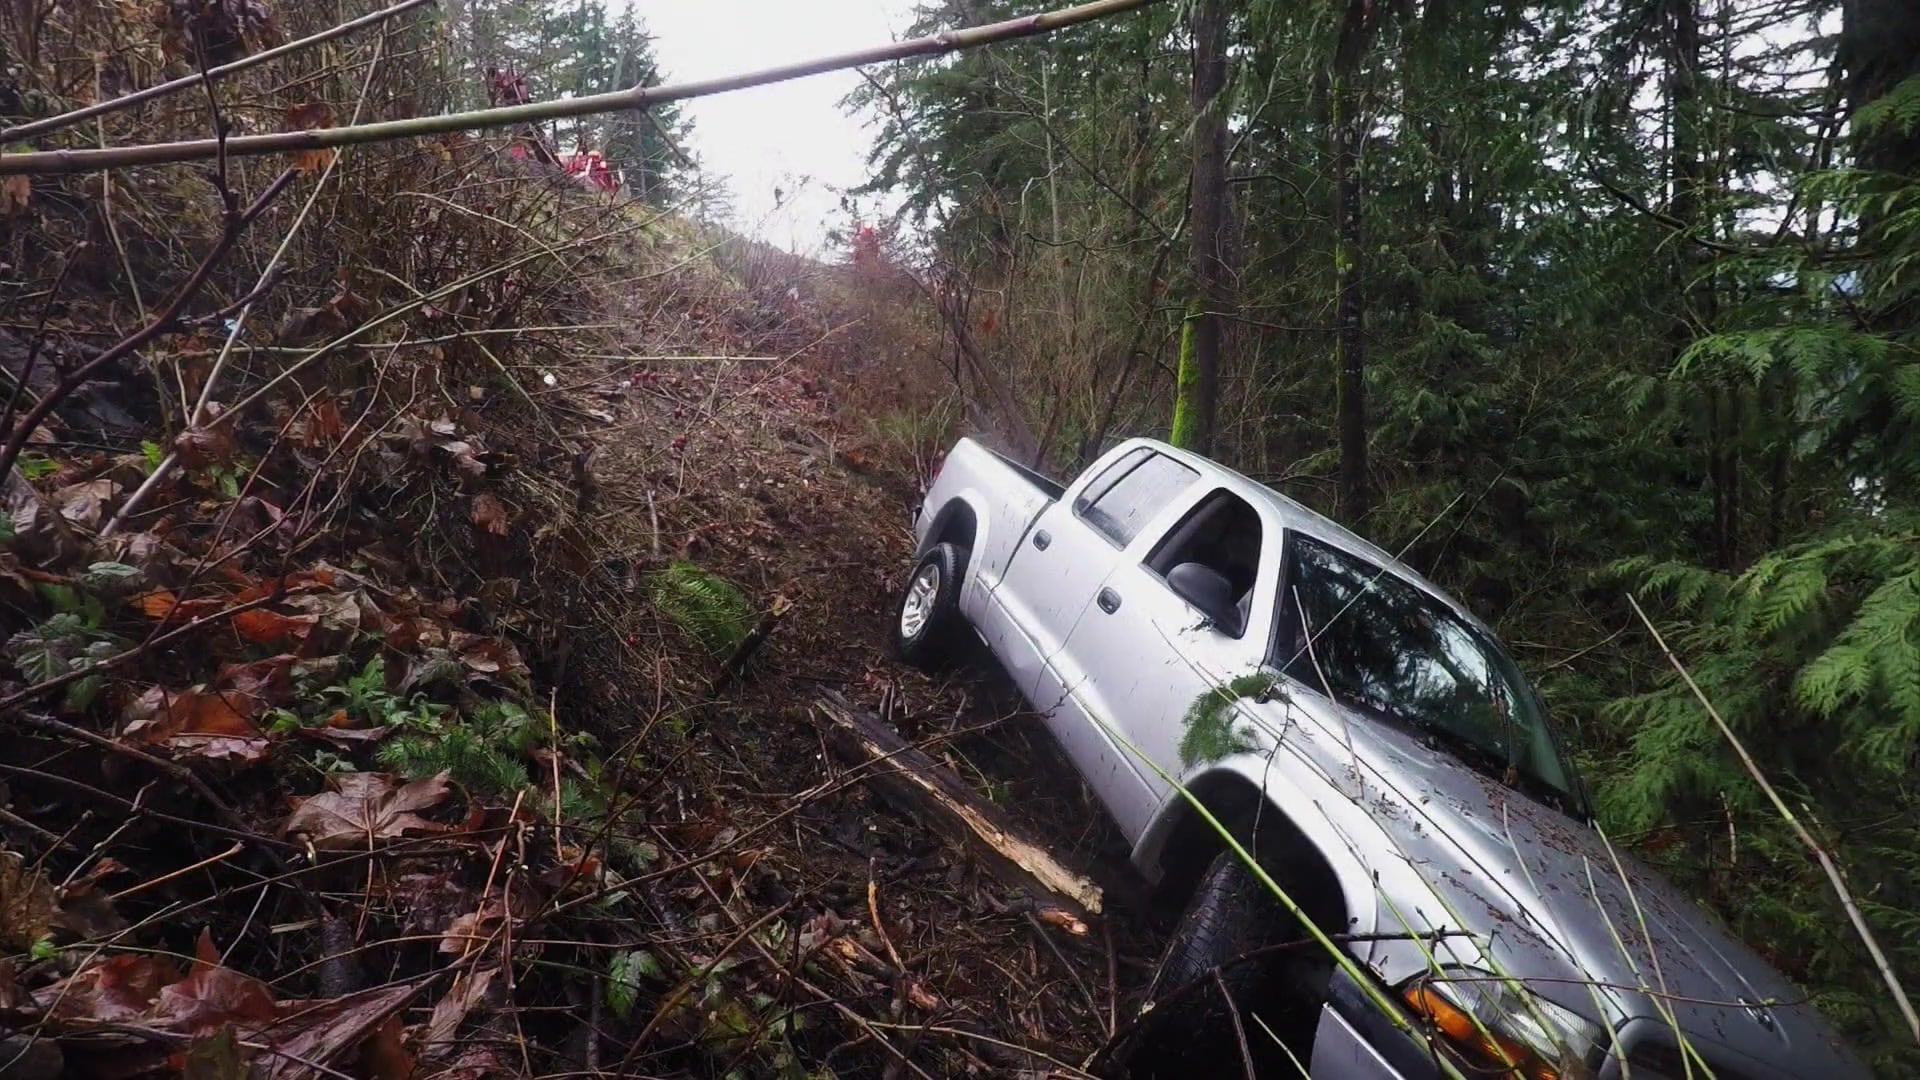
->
[989,446,1200,822]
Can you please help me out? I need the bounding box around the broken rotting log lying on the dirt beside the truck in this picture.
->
[814,690,1102,936]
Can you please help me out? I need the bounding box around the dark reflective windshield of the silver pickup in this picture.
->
[1275,532,1584,813]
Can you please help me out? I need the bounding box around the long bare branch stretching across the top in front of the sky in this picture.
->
[0,0,1160,177]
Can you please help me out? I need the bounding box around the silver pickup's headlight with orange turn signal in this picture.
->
[1400,969,1607,1080]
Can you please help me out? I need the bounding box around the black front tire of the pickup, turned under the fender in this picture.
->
[1116,851,1332,1080]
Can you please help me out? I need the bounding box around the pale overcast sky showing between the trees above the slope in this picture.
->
[632,0,914,254]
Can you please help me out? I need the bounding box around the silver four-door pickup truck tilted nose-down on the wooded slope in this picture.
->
[893,440,1866,1080]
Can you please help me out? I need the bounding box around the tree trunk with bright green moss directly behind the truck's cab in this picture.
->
[1173,0,1233,454]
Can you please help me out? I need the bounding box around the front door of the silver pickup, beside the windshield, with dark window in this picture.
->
[1054,488,1279,840]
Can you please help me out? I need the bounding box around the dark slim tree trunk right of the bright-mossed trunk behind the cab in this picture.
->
[1327,0,1373,523]
